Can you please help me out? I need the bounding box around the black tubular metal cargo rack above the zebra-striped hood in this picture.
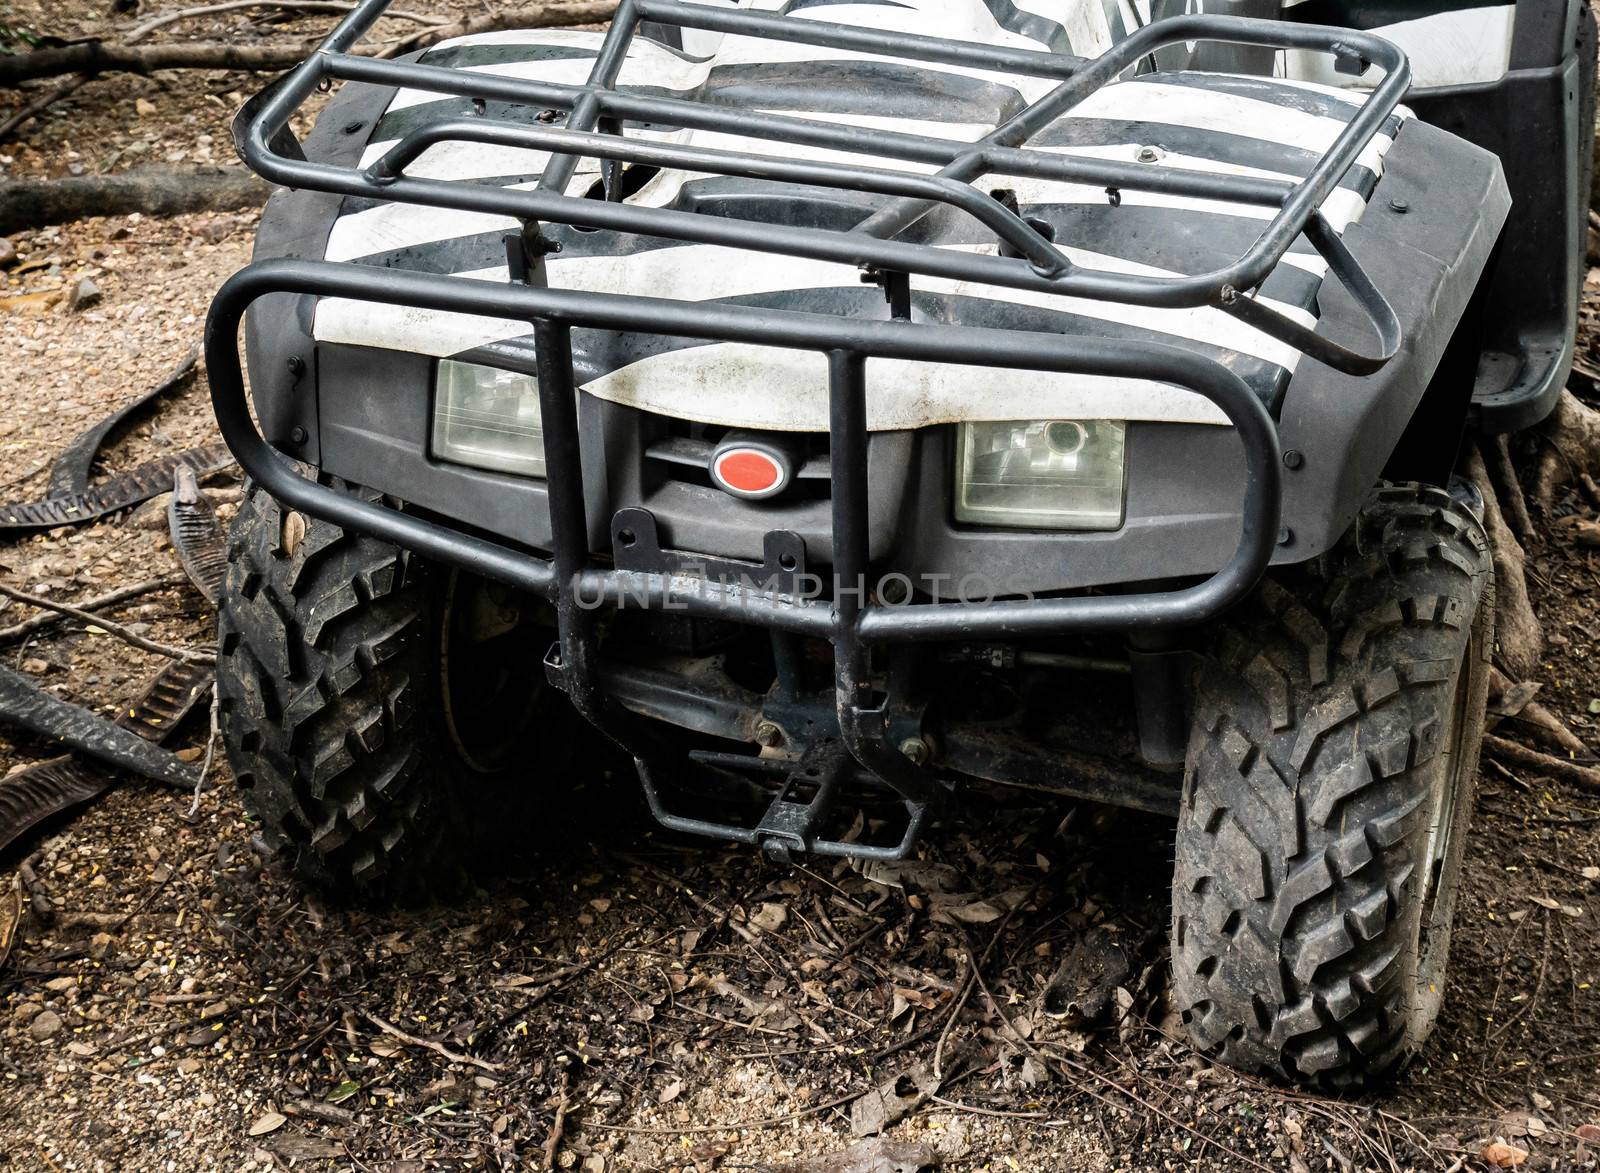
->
[235,0,1410,334]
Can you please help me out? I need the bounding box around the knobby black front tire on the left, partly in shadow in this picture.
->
[218,488,566,899]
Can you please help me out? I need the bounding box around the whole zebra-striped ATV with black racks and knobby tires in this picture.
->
[206,0,1595,1087]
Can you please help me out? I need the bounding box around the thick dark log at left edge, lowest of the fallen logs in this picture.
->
[0,165,272,235]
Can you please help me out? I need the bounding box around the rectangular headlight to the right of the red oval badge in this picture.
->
[955,419,1126,530]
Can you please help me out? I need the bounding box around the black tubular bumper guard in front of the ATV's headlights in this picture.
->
[206,261,1282,858]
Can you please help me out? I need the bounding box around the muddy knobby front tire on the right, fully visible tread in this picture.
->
[1173,486,1494,1088]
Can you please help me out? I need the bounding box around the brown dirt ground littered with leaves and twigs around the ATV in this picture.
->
[0,2,1600,1173]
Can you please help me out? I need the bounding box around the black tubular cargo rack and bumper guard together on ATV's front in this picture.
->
[206,0,1410,858]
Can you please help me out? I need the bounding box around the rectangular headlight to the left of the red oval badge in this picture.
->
[434,358,544,477]
